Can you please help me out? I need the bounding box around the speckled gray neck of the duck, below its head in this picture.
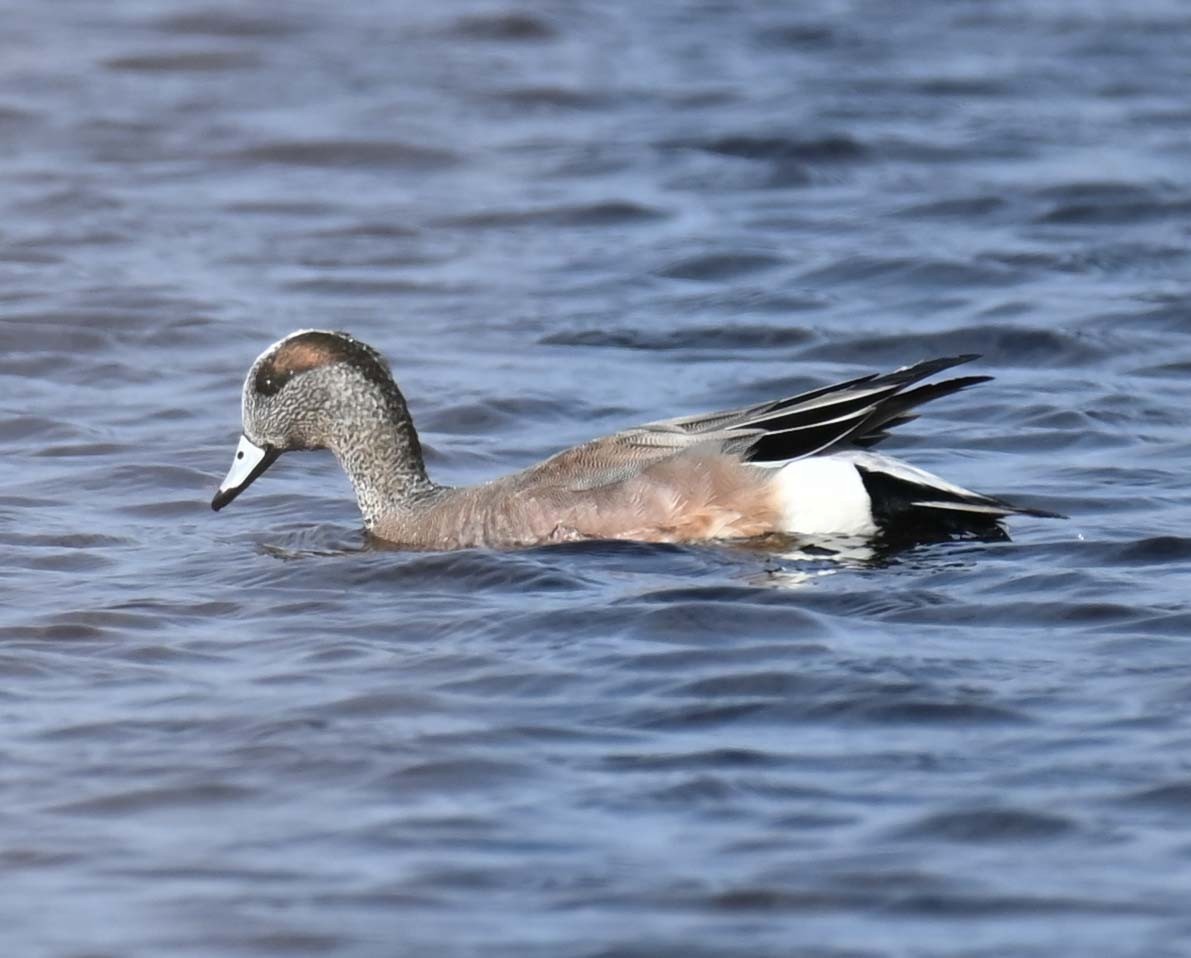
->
[330,388,439,529]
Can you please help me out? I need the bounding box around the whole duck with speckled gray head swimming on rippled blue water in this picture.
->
[211,329,1060,550]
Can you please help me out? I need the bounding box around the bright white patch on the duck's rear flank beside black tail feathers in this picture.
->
[773,455,877,535]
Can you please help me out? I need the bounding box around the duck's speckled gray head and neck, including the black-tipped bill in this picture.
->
[211,329,429,524]
